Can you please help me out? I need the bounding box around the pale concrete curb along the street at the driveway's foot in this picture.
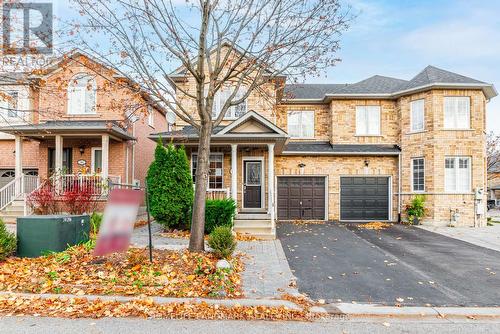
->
[330,303,500,317]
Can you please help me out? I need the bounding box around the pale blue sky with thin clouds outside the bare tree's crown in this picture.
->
[53,0,500,134]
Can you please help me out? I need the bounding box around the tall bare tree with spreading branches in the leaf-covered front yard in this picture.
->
[72,0,352,251]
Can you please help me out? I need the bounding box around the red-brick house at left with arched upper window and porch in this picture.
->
[0,51,167,220]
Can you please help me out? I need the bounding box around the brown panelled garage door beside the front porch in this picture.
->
[278,176,325,220]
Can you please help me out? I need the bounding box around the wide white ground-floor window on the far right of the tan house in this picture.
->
[444,157,471,193]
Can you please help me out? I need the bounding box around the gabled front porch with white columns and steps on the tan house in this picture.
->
[150,111,288,238]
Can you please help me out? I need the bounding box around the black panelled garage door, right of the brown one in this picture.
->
[340,177,389,220]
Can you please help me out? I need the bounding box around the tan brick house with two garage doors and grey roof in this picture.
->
[151,66,497,236]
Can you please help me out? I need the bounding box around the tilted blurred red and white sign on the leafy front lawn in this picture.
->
[94,189,144,256]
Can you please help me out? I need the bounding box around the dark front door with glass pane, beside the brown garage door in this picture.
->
[243,160,262,208]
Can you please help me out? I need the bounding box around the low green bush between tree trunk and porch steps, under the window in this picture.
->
[205,198,236,234]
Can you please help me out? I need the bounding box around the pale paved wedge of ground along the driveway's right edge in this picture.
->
[418,224,500,252]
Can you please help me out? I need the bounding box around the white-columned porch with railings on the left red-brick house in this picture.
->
[0,121,134,213]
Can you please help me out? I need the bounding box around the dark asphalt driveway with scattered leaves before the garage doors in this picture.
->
[277,222,500,306]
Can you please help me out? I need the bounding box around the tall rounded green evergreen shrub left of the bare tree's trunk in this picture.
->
[147,140,193,227]
